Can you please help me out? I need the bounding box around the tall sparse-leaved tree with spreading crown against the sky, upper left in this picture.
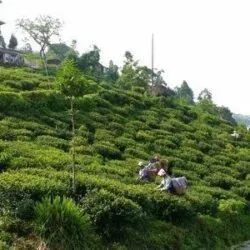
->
[17,16,62,76]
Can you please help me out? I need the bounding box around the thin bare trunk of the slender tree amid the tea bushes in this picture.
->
[70,96,76,194]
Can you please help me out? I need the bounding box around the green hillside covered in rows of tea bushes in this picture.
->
[0,65,250,249]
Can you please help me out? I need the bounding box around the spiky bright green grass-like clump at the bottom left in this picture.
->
[35,196,100,250]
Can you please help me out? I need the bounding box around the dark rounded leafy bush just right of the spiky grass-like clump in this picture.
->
[82,189,144,242]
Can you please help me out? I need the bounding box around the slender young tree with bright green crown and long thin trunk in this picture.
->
[57,60,88,193]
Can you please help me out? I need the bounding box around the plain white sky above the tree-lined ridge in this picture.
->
[0,0,250,115]
